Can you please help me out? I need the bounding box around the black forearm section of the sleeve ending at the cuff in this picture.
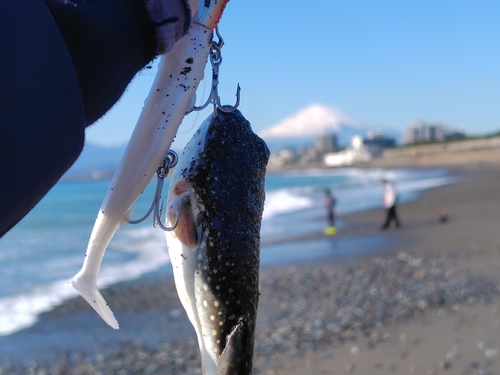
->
[45,0,191,125]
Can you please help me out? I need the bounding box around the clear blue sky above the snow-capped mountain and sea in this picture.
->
[87,0,500,146]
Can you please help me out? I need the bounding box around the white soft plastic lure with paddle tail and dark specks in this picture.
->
[71,0,228,329]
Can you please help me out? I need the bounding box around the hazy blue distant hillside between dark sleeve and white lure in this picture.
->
[63,143,127,179]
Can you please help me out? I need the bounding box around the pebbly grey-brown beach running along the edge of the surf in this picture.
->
[0,164,500,375]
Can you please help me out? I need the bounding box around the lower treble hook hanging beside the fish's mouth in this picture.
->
[128,150,179,232]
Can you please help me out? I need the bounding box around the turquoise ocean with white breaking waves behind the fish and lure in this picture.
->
[0,168,456,335]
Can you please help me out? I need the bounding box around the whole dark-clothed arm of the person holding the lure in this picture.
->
[0,0,191,237]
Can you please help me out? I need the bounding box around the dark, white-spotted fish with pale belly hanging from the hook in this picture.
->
[166,110,269,375]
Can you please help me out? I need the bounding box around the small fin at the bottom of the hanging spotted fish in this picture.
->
[216,319,252,375]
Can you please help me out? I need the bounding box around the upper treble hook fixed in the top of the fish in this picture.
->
[192,26,241,115]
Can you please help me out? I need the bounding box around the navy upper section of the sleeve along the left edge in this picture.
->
[0,0,85,236]
